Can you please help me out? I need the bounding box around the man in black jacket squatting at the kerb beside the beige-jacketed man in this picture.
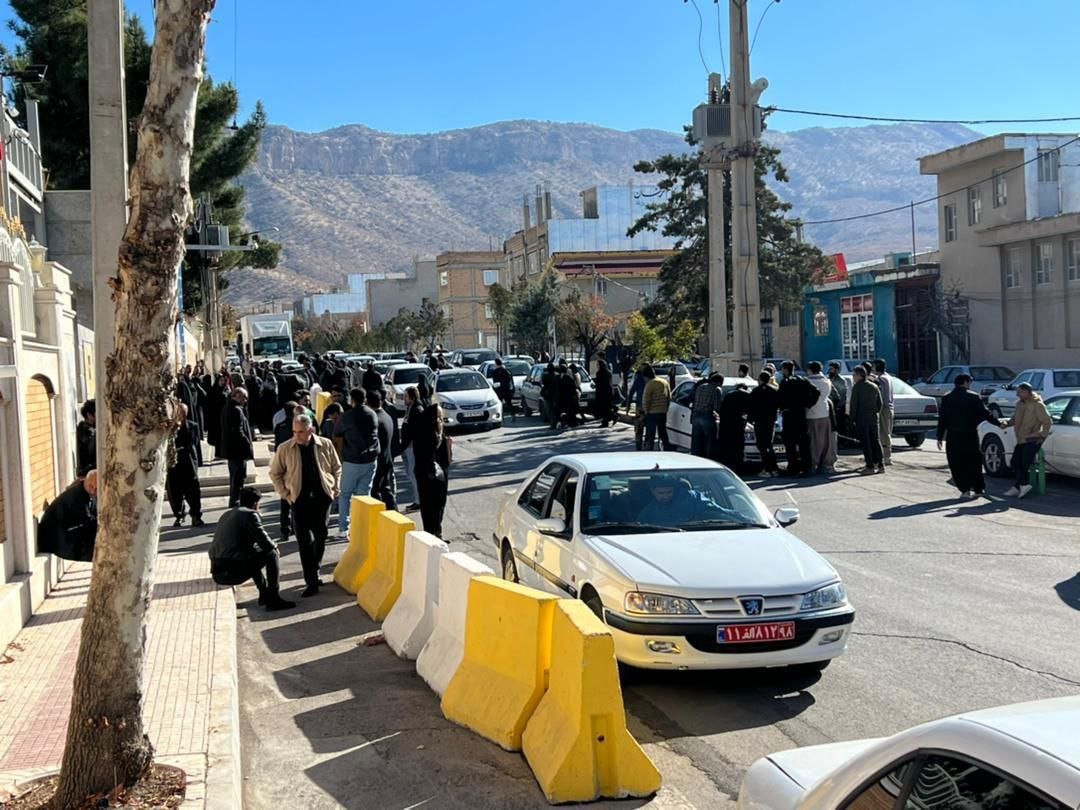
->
[210,487,296,610]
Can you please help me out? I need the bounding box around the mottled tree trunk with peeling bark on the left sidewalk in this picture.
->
[53,0,214,808]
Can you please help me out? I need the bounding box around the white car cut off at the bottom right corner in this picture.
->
[739,697,1080,810]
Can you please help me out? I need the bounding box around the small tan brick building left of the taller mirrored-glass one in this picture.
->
[435,251,509,349]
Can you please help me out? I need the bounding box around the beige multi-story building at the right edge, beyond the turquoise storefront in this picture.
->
[919,134,1080,368]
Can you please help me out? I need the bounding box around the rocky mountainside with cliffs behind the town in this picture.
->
[229,121,977,302]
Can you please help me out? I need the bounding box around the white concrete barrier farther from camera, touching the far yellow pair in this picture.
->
[382,531,446,660]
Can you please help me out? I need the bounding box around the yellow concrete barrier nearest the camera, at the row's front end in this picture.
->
[520,599,660,804]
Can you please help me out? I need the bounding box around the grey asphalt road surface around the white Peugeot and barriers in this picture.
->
[239,418,1080,808]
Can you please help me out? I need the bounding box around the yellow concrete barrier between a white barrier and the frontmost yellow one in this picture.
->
[443,577,558,751]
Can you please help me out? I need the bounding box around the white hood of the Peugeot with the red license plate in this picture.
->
[586,528,837,598]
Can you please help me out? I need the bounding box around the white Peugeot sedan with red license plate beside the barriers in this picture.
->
[494,453,854,670]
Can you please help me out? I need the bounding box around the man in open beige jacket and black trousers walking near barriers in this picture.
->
[270,414,341,596]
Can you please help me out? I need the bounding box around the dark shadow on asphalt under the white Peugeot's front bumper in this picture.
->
[620,666,822,743]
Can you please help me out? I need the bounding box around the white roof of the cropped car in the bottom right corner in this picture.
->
[960,696,1080,768]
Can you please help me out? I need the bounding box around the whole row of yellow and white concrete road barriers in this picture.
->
[334,497,660,804]
